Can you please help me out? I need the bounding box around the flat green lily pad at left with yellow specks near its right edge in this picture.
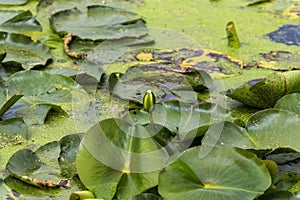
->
[6,70,76,105]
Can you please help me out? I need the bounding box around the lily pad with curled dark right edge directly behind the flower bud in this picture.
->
[109,66,211,104]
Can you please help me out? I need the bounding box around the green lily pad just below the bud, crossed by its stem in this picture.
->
[124,101,236,140]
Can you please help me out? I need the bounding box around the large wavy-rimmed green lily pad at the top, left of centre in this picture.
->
[51,6,147,40]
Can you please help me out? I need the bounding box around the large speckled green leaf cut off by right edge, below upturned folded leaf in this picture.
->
[246,109,300,151]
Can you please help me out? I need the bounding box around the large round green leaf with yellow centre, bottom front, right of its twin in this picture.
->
[158,146,271,200]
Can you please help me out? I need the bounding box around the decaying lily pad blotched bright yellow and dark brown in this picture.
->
[111,48,245,78]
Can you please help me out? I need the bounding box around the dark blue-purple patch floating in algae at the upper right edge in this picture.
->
[267,24,300,46]
